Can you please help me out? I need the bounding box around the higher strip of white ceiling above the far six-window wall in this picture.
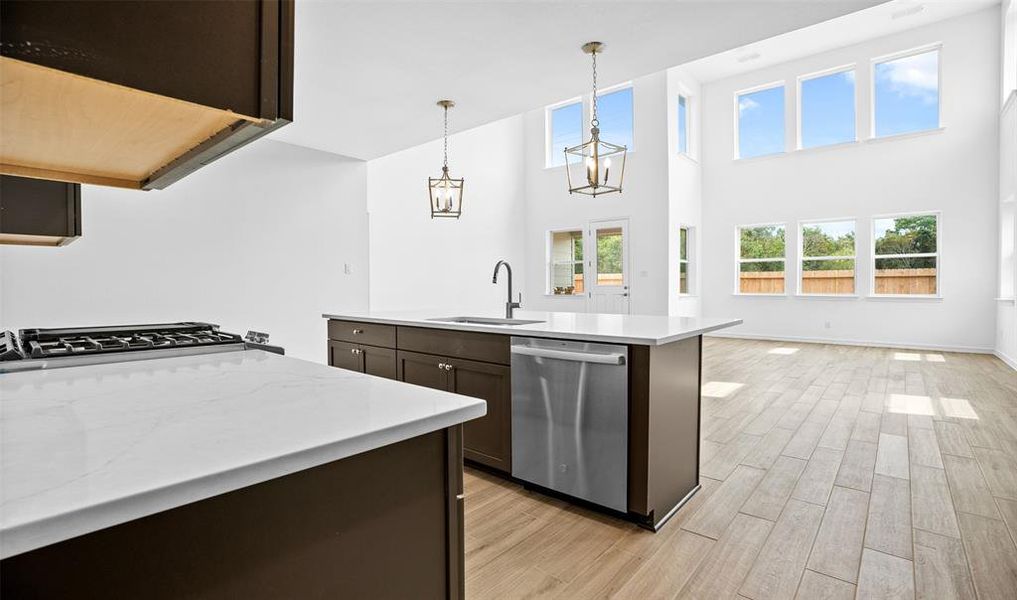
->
[682,0,1000,82]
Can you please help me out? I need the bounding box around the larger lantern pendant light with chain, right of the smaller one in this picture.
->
[565,42,629,196]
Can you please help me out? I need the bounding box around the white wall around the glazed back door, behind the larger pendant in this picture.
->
[524,71,668,314]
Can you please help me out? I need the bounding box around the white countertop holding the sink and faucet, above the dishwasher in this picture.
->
[322,310,741,346]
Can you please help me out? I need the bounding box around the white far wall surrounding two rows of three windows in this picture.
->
[701,7,1000,351]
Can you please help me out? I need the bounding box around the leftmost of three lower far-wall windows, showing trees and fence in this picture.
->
[738,225,785,294]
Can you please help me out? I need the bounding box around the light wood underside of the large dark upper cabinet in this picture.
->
[0,57,274,189]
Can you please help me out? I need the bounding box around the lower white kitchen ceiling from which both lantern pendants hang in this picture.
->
[273,0,883,160]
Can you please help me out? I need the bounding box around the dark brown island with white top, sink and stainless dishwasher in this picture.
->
[322,310,741,530]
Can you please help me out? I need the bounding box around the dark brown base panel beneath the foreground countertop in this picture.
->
[0,426,464,600]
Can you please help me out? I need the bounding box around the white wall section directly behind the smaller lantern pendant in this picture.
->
[367,115,531,316]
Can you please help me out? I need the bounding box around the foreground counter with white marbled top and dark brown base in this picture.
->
[0,350,485,598]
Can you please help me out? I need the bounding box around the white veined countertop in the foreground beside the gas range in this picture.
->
[0,350,487,557]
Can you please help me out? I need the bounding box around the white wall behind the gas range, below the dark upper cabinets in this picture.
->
[0,139,367,362]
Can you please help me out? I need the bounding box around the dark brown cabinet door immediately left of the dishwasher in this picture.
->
[450,359,512,473]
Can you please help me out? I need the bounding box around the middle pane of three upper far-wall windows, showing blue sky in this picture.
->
[801,70,855,147]
